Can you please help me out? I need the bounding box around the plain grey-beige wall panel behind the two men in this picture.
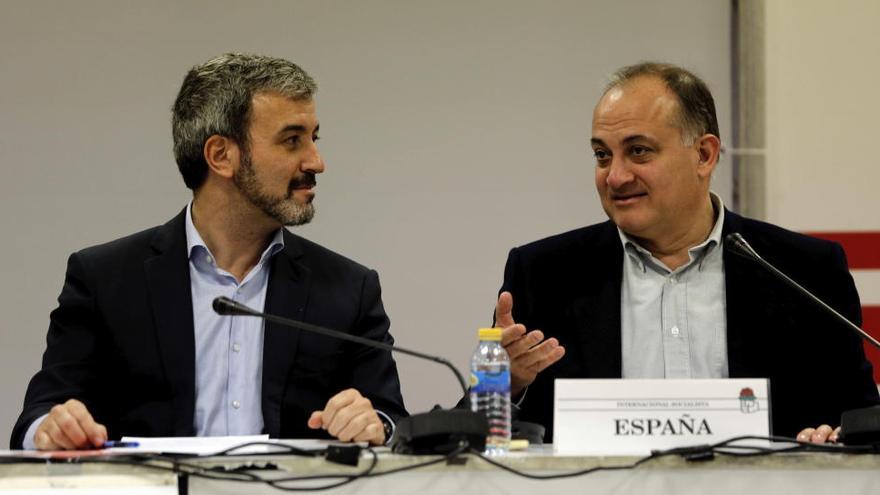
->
[0,0,728,442]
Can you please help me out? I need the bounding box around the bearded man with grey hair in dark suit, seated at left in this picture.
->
[11,54,406,449]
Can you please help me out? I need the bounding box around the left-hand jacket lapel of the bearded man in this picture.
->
[144,208,195,436]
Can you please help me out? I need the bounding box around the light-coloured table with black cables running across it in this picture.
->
[0,446,880,495]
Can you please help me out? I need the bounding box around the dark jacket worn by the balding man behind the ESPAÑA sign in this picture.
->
[502,211,878,441]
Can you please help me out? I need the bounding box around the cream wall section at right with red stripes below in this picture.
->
[766,0,880,306]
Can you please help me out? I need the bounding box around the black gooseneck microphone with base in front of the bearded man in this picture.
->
[211,296,489,455]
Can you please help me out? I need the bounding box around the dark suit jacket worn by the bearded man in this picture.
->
[11,210,406,448]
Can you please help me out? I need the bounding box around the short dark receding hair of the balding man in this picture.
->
[605,62,721,144]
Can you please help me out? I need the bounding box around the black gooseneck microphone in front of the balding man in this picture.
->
[724,232,880,444]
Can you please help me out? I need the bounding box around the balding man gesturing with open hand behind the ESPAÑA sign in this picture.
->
[496,63,878,442]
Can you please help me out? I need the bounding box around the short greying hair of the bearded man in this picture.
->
[171,53,318,190]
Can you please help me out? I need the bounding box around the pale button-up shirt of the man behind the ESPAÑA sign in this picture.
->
[619,193,728,378]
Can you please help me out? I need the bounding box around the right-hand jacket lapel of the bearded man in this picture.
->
[262,229,311,438]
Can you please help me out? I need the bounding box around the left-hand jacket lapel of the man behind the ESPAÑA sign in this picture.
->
[573,221,623,378]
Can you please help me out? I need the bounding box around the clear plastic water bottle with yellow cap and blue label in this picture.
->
[470,328,510,455]
